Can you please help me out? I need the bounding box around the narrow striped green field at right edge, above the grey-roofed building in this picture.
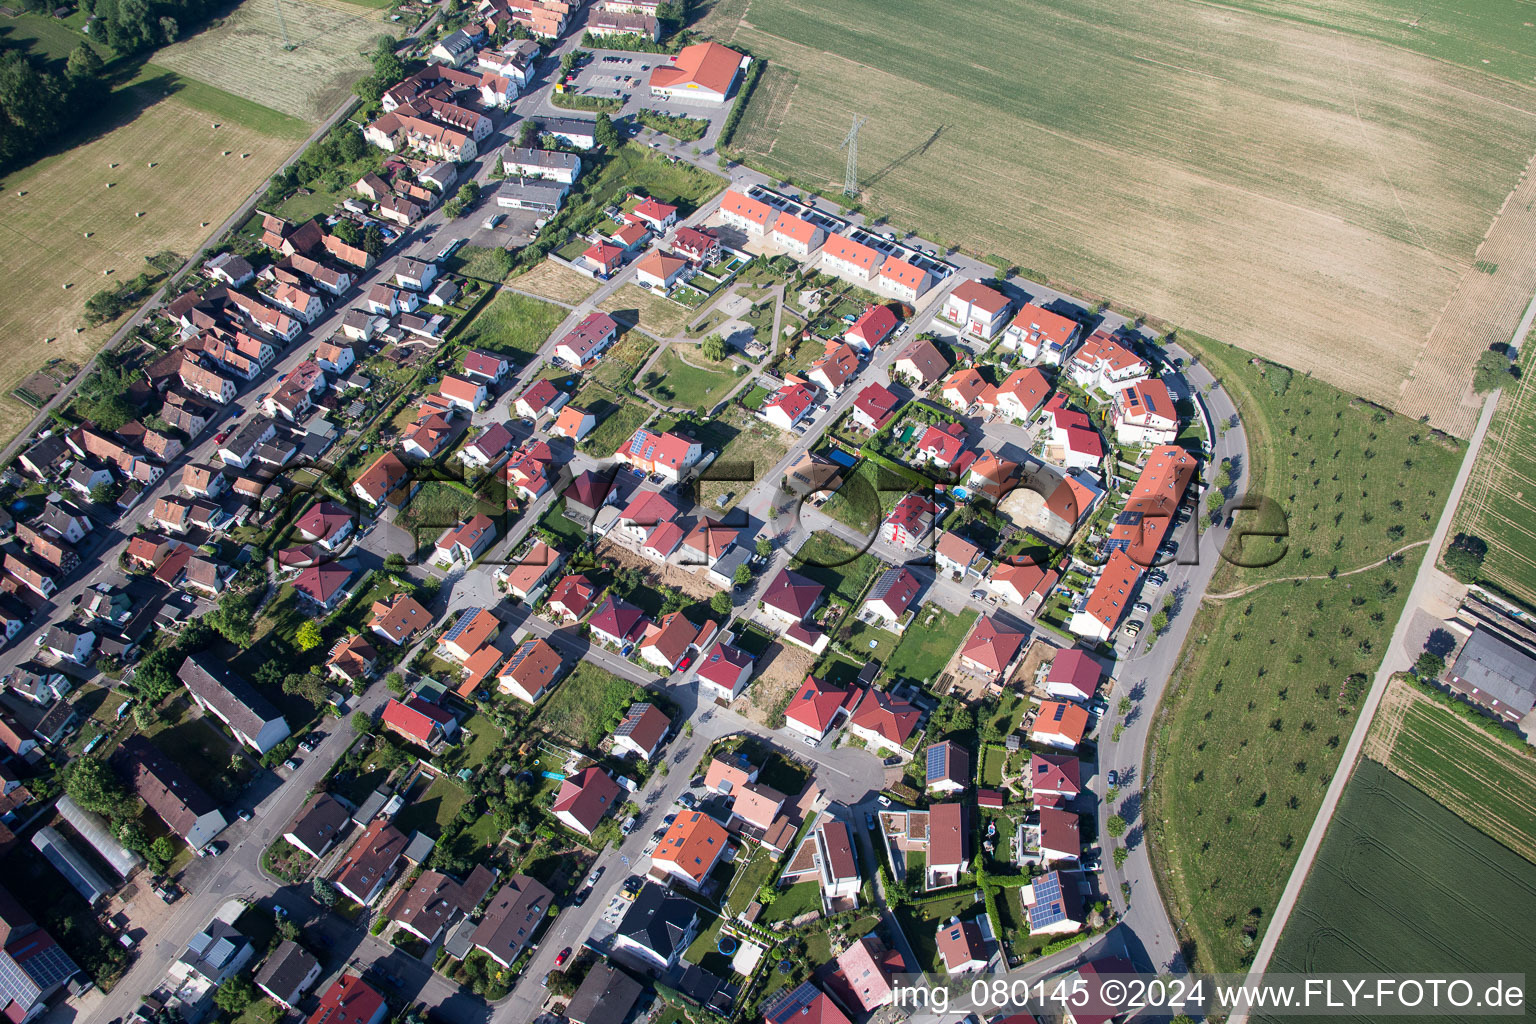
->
[1452,338,1536,606]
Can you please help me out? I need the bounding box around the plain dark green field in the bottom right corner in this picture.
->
[1269,760,1536,1021]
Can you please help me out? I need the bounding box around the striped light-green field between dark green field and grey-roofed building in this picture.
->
[1364,679,1536,863]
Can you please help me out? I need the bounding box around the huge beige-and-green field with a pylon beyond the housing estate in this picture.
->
[700,0,1536,433]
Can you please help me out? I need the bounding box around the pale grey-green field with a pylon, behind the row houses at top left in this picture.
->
[155,0,396,124]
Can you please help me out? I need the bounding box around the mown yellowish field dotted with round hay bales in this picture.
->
[0,97,295,438]
